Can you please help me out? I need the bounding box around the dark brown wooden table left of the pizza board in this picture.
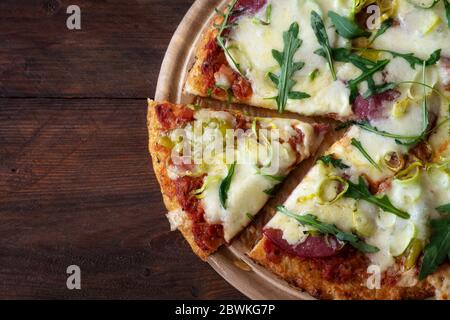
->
[0,0,244,299]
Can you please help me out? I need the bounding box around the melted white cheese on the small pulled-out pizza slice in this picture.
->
[167,109,318,241]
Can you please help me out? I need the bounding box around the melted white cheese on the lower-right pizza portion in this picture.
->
[267,121,450,270]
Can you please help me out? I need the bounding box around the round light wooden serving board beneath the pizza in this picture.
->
[155,0,335,300]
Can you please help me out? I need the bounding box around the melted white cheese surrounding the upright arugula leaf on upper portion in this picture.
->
[228,0,360,117]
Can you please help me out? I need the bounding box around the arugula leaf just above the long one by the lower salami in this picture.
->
[344,177,410,219]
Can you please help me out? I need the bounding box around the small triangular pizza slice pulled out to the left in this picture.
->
[148,101,328,259]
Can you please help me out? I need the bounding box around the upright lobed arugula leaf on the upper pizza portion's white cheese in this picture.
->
[269,22,310,113]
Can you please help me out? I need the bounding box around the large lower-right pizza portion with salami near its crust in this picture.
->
[250,114,450,299]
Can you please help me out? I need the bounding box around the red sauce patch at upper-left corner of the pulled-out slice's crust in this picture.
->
[155,103,194,131]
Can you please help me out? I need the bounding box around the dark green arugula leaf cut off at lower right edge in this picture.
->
[419,217,450,280]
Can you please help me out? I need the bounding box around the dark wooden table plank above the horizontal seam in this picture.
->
[0,0,194,98]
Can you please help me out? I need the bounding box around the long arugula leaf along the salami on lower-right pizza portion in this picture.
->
[276,206,380,253]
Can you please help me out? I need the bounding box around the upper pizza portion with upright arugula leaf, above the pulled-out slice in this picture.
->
[185,0,450,120]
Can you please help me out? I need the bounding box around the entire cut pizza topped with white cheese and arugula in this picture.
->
[149,0,450,299]
